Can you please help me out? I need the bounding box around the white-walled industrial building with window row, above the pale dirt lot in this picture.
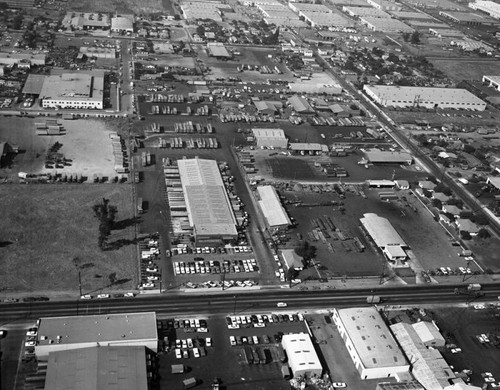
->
[39,71,104,110]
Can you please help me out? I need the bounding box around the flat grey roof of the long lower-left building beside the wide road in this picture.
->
[37,312,158,345]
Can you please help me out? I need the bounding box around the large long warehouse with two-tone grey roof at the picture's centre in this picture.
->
[177,158,238,246]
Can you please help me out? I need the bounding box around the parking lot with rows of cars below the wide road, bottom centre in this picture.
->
[160,314,307,390]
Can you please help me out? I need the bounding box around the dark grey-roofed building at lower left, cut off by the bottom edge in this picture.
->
[45,346,157,390]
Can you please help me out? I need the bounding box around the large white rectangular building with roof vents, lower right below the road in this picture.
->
[332,307,410,380]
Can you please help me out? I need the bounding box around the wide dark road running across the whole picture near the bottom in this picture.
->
[0,283,500,325]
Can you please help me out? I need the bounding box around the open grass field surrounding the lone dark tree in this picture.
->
[0,184,137,293]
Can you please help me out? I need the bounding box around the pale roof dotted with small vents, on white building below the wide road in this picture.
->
[337,307,408,368]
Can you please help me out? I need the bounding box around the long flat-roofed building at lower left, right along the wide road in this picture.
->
[35,312,158,361]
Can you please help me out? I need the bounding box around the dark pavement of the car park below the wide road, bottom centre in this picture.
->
[160,314,307,390]
